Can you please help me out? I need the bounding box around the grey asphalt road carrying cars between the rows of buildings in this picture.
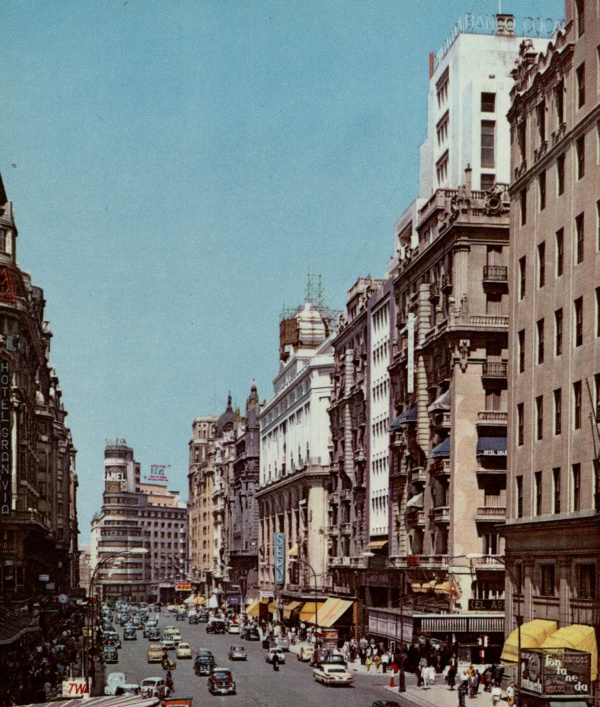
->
[106,614,422,707]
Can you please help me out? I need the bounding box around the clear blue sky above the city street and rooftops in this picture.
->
[0,0,564,543]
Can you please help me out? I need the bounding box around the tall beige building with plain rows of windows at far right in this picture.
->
[503,0,600,706]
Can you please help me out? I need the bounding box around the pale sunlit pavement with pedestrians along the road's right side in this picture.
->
[290,644,504,707]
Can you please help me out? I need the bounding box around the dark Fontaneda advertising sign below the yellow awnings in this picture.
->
[521,648,592,697]
